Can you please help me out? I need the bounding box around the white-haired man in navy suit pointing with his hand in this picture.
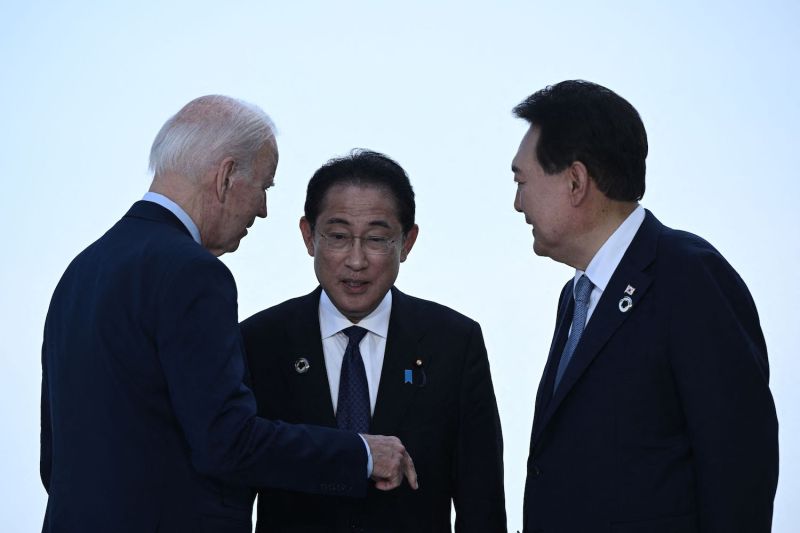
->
[41,96,416,533]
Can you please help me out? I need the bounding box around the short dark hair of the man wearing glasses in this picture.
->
[305,148,416,235]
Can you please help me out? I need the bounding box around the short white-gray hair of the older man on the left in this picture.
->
[150,95,275,183]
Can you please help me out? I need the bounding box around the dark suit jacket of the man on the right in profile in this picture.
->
[524,212,778,533]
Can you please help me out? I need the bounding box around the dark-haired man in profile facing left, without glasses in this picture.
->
[512,81,778,533]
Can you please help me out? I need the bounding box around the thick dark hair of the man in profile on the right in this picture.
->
[514,80,647,201]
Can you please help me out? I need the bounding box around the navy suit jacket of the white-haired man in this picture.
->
[41,201,367,533]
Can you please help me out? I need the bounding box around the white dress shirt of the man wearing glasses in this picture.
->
[319,291,392,414]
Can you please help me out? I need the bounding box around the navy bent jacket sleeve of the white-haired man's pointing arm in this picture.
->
[156,256,367,496]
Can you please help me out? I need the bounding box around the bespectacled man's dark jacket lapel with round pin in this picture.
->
[281,287,336,427]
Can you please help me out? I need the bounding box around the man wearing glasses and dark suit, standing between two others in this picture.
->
[242,150,506,533]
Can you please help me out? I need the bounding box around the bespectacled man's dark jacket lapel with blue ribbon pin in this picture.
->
[370,288,430,435]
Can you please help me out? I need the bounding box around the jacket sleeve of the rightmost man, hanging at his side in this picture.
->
[670,253,778,533]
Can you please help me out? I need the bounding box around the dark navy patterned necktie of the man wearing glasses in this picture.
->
[336,326,370,433]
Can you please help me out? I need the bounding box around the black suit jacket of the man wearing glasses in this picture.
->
[242,288,506,533]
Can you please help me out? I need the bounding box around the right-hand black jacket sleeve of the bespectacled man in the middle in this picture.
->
[453,323,506,533]
